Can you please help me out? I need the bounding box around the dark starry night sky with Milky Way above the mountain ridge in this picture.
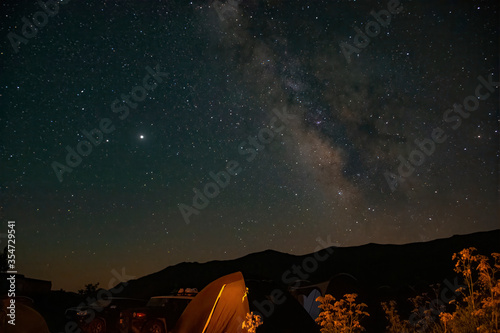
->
[0,0,500,291]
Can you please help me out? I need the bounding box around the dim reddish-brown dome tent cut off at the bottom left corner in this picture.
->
[0,299,50,333]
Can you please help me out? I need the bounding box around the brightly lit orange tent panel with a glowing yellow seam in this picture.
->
[174,272,250,333]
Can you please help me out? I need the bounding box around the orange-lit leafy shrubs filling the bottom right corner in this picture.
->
[382,247,500,333]
